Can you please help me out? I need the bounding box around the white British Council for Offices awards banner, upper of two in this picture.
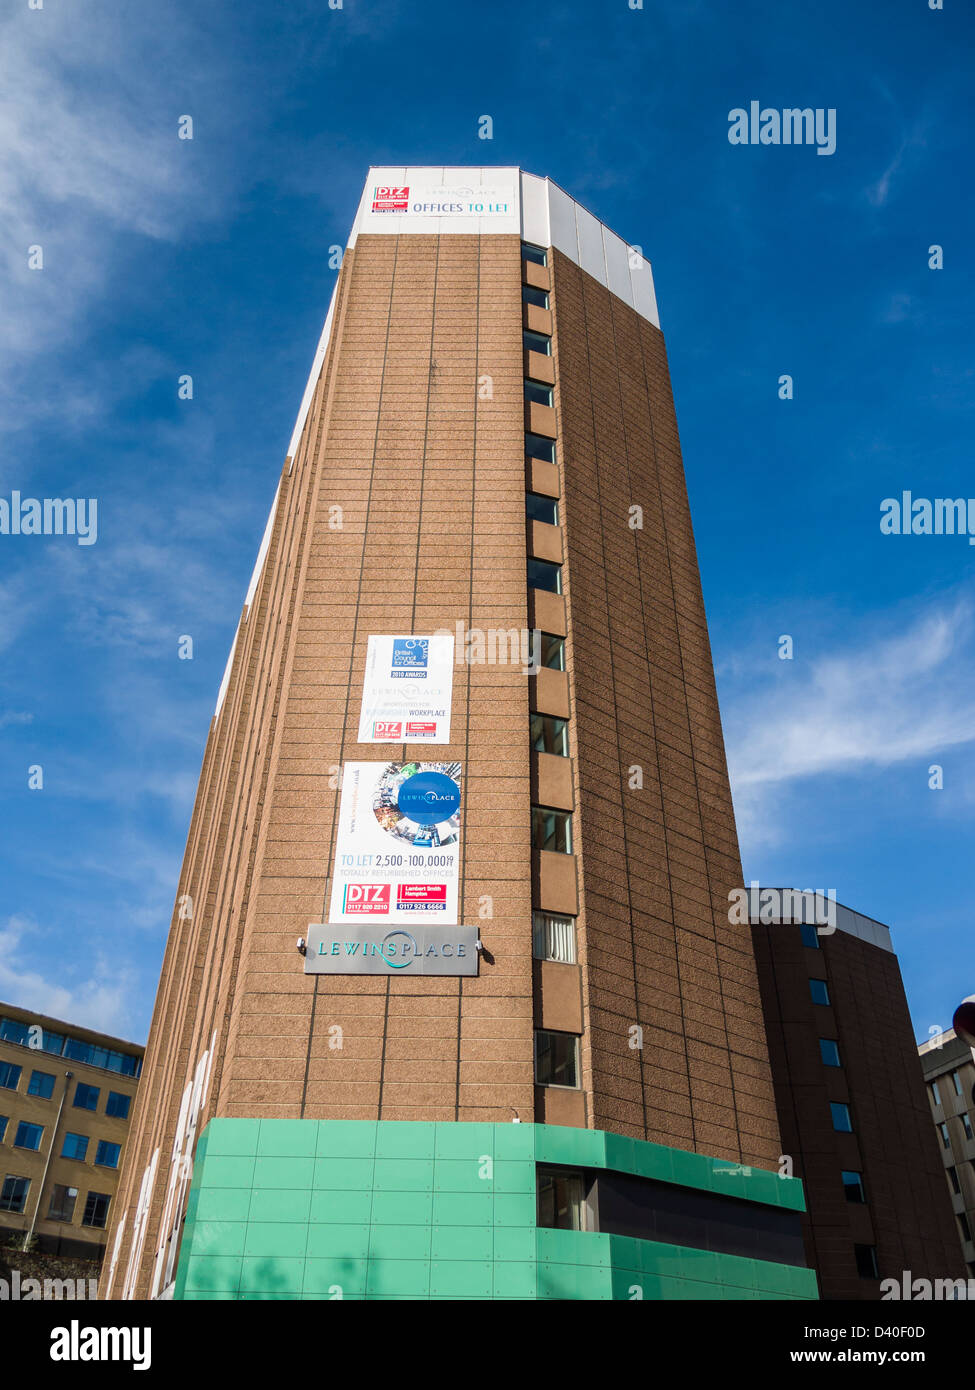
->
[359,634,453,744]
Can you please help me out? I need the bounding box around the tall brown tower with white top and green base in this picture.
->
[103,168,815,1298]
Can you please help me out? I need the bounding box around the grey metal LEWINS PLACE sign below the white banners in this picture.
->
[305,922,477,976]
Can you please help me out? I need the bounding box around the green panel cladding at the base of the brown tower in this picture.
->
[174,1119,818,1300]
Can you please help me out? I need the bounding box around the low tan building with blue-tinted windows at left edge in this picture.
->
[0,1004,143,1259]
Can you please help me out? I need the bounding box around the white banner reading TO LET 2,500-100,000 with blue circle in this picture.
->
[328,763,460,940]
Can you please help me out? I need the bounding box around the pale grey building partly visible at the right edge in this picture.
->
[918,1029,975,1279]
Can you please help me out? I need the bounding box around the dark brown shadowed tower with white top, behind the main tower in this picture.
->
[751,888,965,1298]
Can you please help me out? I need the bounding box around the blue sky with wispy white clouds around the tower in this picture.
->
[0,0,975,1038]
